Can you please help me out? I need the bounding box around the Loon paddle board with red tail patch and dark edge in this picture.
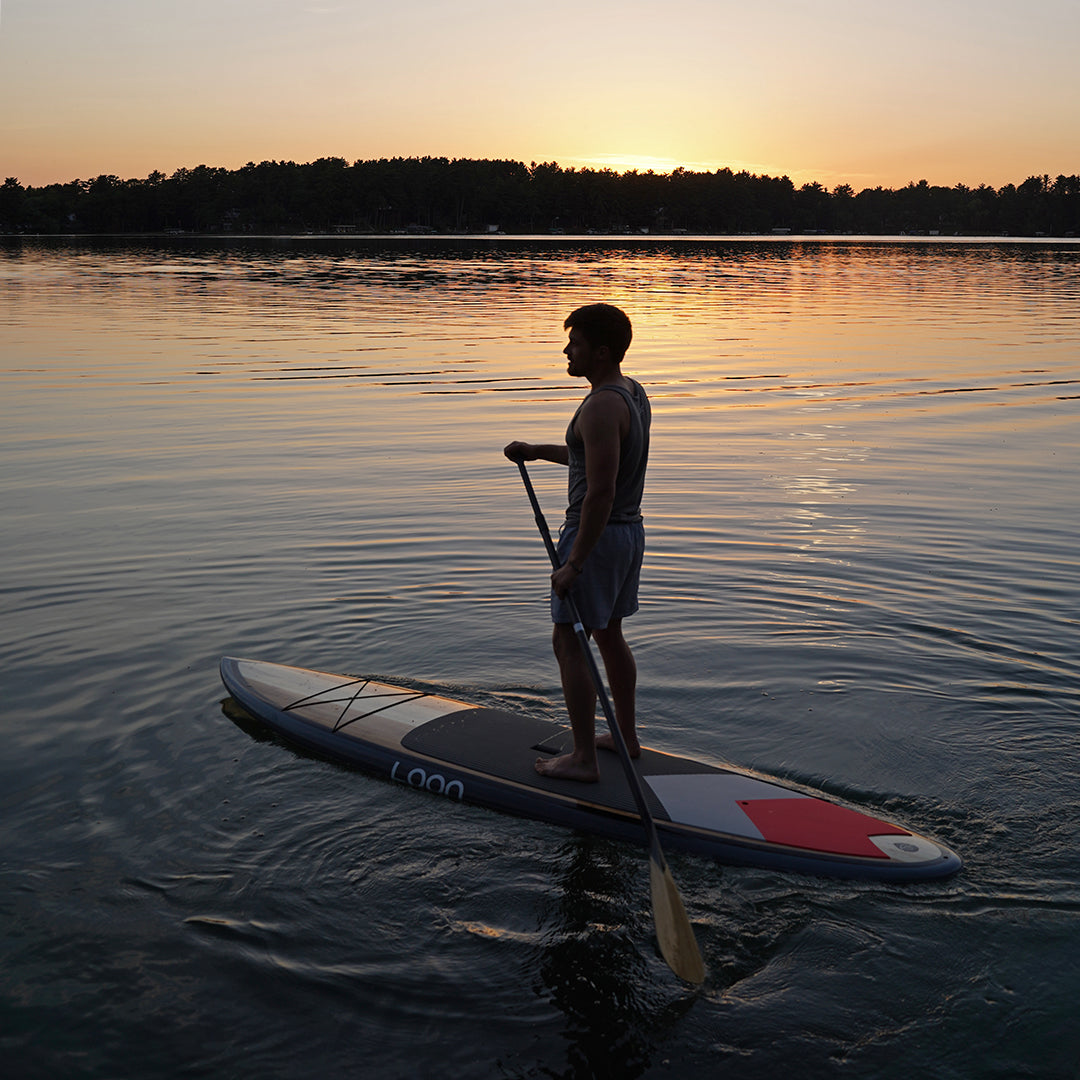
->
[221,657,961,881]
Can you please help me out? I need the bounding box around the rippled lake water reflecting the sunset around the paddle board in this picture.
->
[6,238,1080,1080]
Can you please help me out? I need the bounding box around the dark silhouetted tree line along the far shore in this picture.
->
[0,158,1080,237]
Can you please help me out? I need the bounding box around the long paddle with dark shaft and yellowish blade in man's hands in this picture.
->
[517,459,705,983]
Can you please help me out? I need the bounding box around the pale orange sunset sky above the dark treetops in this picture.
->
[0,0,1080,190]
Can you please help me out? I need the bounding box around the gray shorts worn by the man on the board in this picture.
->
[551,522,645,630]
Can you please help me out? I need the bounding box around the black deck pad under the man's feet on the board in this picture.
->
[402,708,725,821]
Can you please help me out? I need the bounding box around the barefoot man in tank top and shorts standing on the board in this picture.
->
[503,303,651,782]
